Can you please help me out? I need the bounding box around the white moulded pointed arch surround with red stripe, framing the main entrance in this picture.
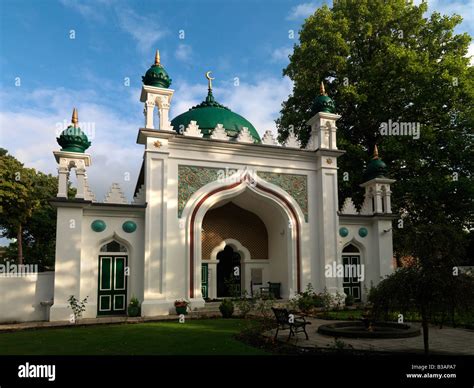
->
[183,171,304,299]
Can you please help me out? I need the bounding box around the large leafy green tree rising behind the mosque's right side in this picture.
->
[277,0,474,262]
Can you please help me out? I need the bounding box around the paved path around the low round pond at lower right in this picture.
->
[265,318,474,355]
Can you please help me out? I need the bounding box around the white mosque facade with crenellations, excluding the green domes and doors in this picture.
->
[0,77,393,321]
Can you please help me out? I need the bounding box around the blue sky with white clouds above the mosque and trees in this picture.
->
[0,0,474,205]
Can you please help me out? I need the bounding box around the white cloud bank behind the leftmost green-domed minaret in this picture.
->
[0,88,143,200]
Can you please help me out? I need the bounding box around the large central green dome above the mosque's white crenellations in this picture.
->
[171,90,260,143]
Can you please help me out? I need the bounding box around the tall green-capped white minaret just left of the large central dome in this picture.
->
[140,50,174,131]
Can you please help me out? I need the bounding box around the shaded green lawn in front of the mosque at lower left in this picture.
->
[0,319,268,355]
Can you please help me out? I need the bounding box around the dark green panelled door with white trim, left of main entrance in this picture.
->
[97,255,127,315]
